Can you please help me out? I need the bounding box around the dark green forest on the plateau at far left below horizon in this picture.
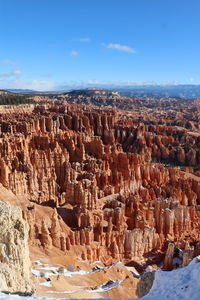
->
[0,94,35,105]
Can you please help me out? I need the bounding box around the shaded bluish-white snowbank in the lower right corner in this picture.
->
[140,256,200,300]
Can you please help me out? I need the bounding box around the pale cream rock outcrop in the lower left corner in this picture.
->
[0,202,33,294]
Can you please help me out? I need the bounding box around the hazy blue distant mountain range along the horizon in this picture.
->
[3,84,200,99]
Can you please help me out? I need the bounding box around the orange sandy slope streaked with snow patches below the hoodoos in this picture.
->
[32,247,138,299]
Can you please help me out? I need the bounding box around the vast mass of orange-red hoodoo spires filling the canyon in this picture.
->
[0,102,200,268]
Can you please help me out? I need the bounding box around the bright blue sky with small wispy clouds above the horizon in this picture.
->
[0,0,200,90]
